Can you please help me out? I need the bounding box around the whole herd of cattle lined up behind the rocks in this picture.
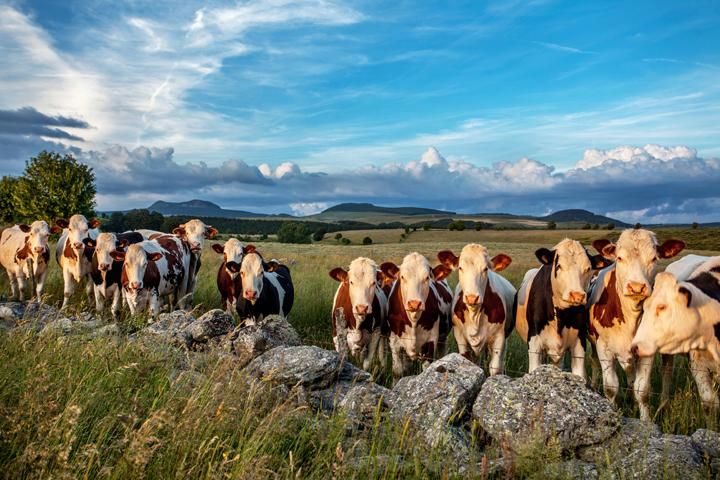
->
[0,215,720,419]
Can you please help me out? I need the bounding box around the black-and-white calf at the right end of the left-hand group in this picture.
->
[237,245,295,322]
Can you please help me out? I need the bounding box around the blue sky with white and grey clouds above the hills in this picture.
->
[0,0,720,221]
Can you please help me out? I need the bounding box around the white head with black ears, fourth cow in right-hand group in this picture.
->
[535,238,611,308]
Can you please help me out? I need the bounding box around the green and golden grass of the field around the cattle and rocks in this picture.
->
[0,229,720,478]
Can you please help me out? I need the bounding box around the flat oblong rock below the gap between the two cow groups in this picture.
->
[244,346,342,390]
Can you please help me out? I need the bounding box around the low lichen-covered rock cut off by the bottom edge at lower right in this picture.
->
[610,435,709,480]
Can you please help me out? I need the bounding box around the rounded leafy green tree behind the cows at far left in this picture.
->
[13,150,97,221]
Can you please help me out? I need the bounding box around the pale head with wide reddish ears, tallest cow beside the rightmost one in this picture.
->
[593,229,685,302]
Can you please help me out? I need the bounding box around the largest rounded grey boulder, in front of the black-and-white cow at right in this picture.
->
[473,365,621,451]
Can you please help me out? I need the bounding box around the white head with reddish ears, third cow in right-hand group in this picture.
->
[438,243,512,310]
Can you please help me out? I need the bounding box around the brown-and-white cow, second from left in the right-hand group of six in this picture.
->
[380,252,452,378]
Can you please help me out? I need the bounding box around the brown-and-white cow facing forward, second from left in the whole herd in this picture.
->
[55,214,100,308]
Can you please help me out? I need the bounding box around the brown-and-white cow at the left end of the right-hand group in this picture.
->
[330,257,388,370]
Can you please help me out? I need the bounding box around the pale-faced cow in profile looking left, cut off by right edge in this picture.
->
[632,264,720,410]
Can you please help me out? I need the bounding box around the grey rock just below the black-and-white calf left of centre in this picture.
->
[221,315,301,366]
